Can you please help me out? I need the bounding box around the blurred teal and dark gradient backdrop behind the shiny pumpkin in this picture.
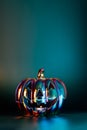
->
[0,0,87,114]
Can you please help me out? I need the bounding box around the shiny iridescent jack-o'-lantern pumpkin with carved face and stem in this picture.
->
[15,69,67,115]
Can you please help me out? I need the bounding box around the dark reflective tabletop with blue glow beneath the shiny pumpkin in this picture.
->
[0,113,87,130]
